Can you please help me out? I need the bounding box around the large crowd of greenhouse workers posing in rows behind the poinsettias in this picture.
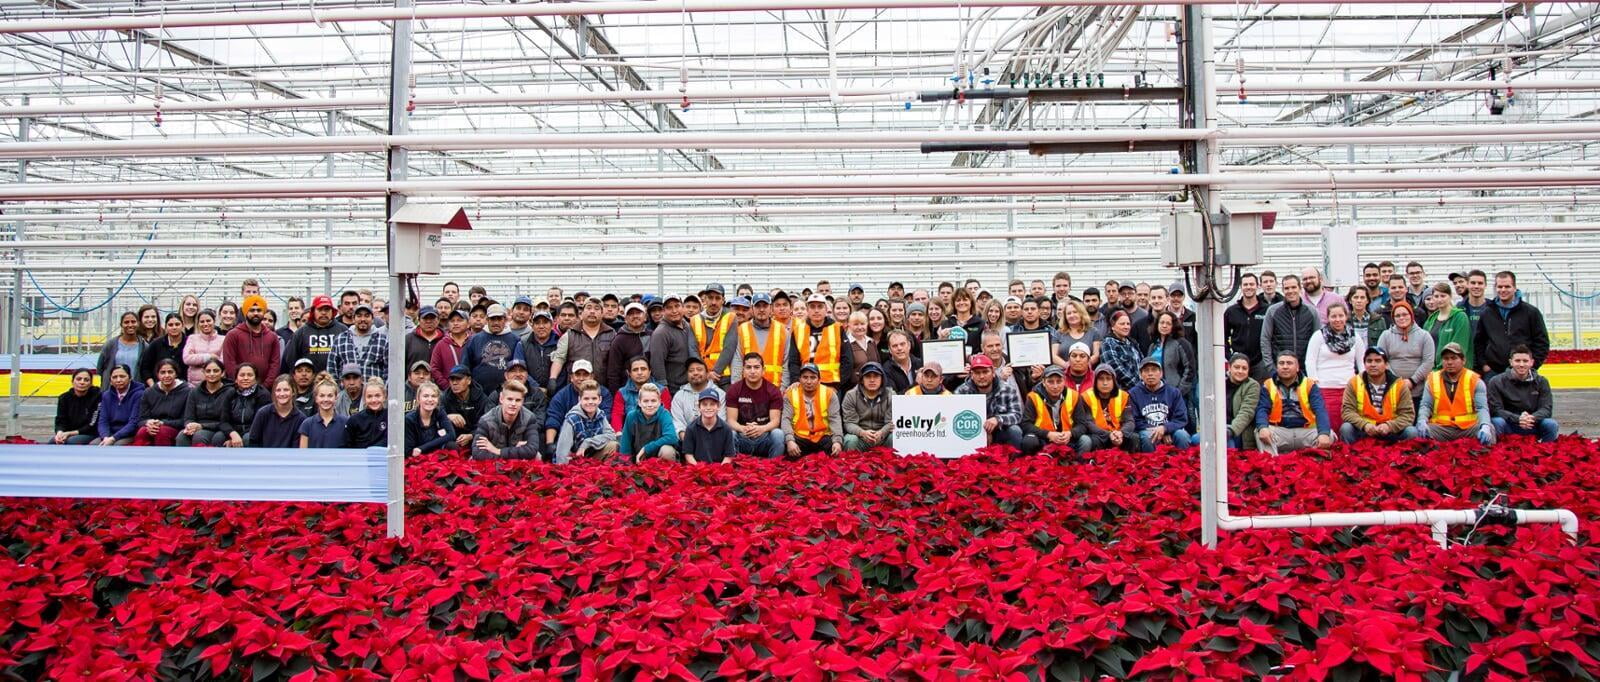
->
[54,263,1558,463]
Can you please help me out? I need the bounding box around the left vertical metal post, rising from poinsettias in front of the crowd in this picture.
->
[384,0,414,538]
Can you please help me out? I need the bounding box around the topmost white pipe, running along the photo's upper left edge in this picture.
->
[0,0,1459,34]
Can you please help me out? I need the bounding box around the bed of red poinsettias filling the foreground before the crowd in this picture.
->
[0,437,1600,680]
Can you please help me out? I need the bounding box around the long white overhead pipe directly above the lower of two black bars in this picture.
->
[9,122,1600,158]
